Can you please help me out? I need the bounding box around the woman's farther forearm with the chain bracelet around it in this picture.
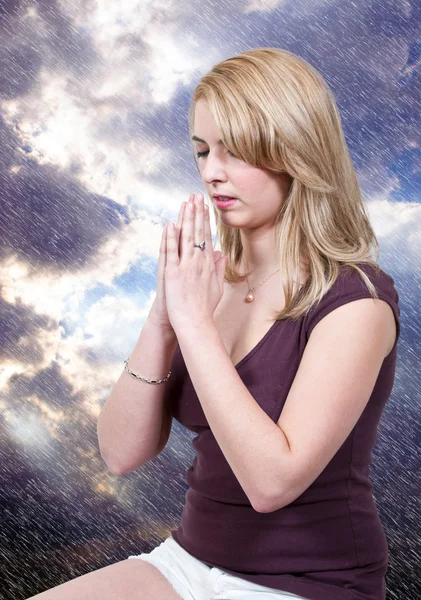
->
[97,321,177,474]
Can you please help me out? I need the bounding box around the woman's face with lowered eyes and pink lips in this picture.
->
[193,99,291,229]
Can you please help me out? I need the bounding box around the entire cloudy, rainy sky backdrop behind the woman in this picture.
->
[0,0,421,600]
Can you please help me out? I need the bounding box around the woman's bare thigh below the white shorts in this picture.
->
[27,559,181,600]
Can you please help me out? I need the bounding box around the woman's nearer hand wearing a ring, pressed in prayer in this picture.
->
[164,195,227,333]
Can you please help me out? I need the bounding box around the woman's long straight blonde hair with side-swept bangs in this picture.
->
[189,48,380,320]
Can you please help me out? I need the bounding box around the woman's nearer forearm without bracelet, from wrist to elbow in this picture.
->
[177,323,290,512]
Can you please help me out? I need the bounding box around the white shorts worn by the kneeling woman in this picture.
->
[128,535,308,600]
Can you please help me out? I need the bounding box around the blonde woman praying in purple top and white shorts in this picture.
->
[28,48,400,600]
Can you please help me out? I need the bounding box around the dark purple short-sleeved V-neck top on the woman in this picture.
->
[164,263,400,600]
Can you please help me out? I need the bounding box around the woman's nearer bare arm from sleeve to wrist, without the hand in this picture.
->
[177,298,395,512]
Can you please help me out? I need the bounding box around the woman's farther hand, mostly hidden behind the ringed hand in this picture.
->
[148,194,225,333]
